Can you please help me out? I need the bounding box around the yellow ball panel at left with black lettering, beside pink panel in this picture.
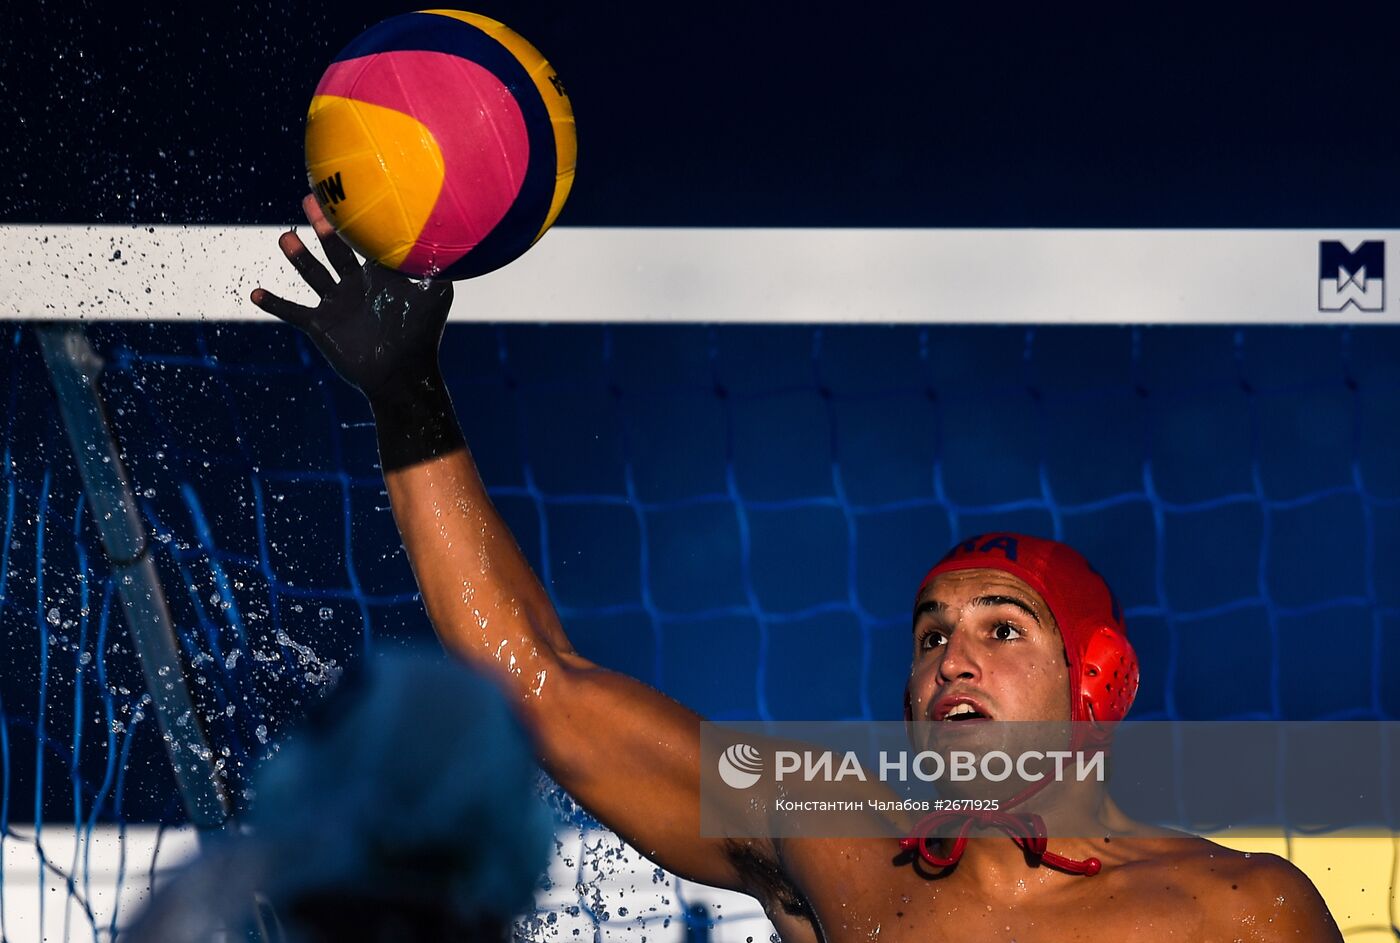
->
[307,95,444,267]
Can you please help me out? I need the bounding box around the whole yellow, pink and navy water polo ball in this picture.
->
[307,10,577,278]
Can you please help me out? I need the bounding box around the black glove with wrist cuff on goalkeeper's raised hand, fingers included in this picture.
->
[252,197,463,472]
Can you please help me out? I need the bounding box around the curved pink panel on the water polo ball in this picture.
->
[316,50,529,273]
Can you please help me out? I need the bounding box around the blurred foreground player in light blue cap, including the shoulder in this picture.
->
[123,652,553,943]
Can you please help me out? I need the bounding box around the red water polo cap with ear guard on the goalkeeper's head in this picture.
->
[918,533,1138,725]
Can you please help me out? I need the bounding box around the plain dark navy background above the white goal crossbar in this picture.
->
[0,0,1400,227]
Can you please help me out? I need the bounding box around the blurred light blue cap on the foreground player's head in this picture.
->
[248,653,553,919]
